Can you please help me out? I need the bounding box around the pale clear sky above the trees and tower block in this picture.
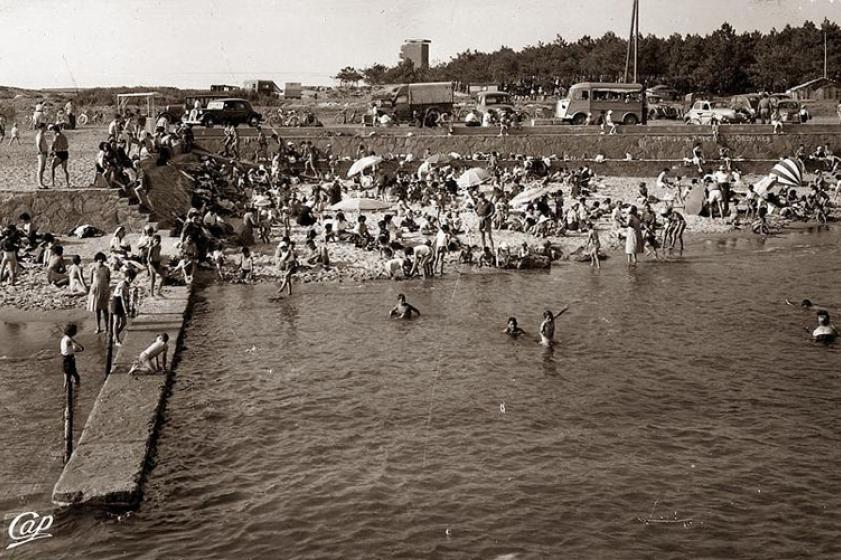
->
[0,0,841,88]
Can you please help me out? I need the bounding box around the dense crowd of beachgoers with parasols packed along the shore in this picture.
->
[0,108,838,323]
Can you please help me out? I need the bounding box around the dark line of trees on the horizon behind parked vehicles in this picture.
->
[336,20,841,95]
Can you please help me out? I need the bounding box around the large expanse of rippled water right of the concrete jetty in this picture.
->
[1,229,841,559]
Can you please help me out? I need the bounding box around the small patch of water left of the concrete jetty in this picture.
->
[0,310,106,516]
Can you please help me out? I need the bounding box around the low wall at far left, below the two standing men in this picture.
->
[0,189,145,234]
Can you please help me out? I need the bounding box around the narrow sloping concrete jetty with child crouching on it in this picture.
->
[52,287,191,507]
